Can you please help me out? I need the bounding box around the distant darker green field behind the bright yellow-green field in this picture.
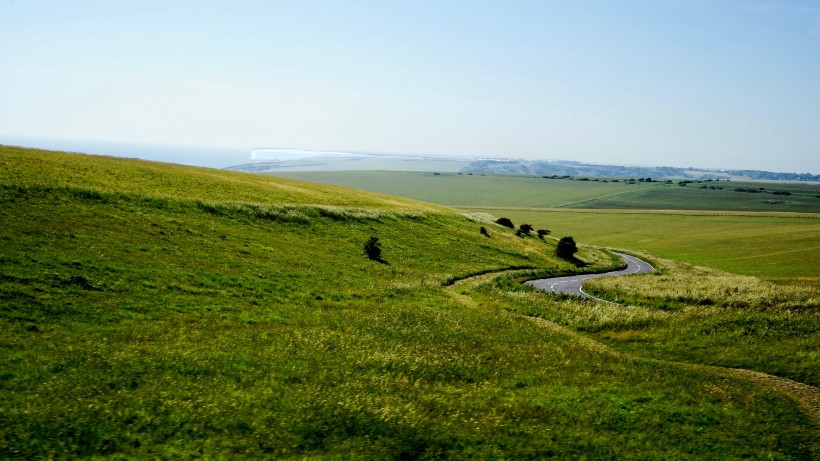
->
[278,171,820,213]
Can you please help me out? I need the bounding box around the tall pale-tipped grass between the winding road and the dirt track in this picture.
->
[506,253,820,386]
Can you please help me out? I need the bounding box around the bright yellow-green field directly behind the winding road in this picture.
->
[464,209,820,284]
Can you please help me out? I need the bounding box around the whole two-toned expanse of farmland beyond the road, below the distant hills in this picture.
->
[278,172,820,286]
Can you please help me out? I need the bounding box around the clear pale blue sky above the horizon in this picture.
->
[0,0,820,174]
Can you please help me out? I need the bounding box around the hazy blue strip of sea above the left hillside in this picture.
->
[0,135,252,168]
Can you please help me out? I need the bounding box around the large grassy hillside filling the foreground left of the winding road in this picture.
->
[0,148,817,459]
